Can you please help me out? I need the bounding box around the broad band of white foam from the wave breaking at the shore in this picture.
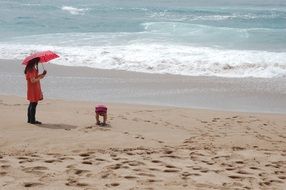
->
[0,44,286,78]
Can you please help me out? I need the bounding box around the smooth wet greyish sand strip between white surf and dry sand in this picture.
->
[0,60,286,114]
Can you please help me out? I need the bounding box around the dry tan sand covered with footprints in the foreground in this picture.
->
[0,95,286,190]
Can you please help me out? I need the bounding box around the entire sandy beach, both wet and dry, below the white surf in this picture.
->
[0,60,286,190]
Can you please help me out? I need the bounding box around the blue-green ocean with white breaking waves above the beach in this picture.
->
[0,0,286,78]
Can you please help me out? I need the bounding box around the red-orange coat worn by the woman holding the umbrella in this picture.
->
[26,68,43,102]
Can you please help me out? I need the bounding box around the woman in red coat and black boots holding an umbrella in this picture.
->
[24,57,47,124]
